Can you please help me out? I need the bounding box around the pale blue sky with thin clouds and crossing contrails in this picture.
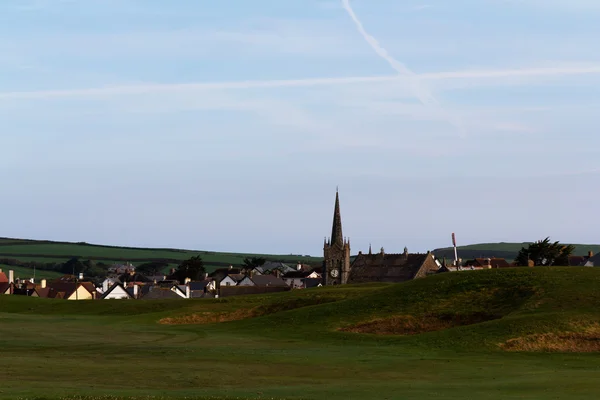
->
[0,0,600,255]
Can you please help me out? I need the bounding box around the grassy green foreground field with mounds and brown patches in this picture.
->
[0,267,600,400]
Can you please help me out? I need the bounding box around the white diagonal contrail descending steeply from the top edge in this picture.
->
[342,0,466,136]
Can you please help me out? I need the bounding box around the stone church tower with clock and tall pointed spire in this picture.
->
[323,191,350,286]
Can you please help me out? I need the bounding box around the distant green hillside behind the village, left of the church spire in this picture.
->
[0,234,321,278]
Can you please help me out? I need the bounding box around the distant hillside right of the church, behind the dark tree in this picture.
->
[433,242,600,261]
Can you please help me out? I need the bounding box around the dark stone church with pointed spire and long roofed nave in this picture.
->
[323,192,441,285]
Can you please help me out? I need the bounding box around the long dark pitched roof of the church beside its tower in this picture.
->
[349,253,431,283]
